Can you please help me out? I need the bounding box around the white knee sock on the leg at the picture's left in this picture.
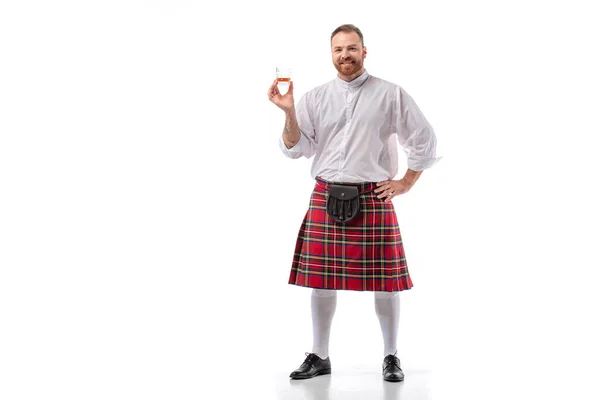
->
[310,289,337,359]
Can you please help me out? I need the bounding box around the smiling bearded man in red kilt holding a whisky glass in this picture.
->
[268,25,439,382]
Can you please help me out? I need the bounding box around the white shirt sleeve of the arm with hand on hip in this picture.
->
[395,87,442,171]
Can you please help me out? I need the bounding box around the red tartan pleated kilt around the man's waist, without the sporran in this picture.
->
[288,177,413,292]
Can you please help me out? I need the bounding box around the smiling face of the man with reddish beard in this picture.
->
[331,32,367,79]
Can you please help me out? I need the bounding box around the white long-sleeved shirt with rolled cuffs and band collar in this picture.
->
[279,71,441,182]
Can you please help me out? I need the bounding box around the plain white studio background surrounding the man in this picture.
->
[0,0,600,400]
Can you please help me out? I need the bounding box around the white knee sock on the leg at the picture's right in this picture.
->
[375,292,400,357]
